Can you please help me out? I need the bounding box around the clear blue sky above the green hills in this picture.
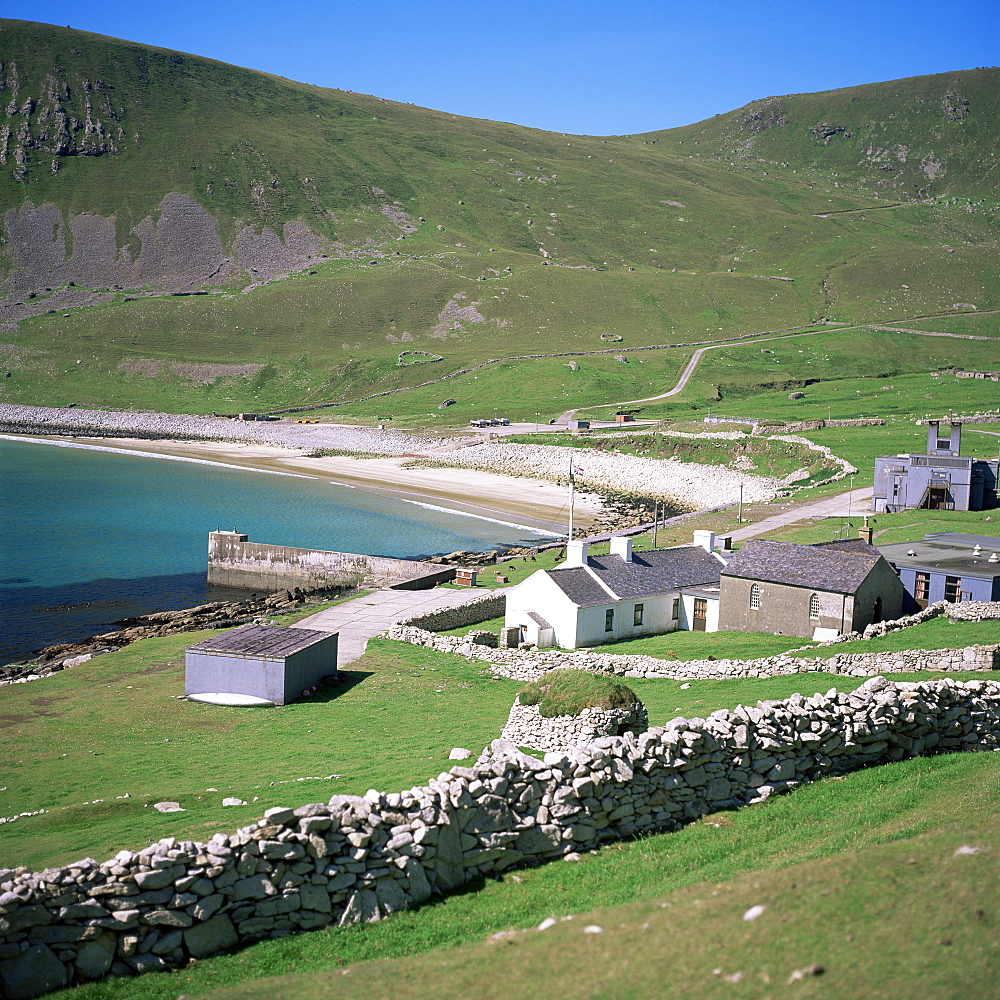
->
[7,0,1000,134]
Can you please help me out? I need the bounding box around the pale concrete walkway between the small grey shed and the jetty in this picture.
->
[296,587,486,670]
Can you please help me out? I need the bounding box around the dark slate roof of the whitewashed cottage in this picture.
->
[549,545,722,608]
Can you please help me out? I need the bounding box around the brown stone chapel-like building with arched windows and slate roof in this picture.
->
[719,538,907,639]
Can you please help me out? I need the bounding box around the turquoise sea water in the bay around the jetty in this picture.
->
[0,440,538,662]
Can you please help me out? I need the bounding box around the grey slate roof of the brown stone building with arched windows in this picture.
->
[722,538,879,594]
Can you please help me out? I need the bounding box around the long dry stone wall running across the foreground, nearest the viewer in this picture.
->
[0,677,1000,998]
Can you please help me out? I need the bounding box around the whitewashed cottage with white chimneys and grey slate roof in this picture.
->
[504,531,725,649]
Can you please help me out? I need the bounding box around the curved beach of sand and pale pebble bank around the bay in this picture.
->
[0,404,783,533]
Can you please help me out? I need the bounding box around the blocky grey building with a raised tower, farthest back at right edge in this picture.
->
[872,420,998,513]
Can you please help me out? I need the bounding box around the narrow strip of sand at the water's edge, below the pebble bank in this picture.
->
[0,431,609,538]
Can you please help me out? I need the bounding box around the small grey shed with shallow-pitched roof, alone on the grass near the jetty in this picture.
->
[184,625,338,705]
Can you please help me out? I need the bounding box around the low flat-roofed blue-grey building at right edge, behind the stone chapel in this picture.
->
[878,531,1000,608]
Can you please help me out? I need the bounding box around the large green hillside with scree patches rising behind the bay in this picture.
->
[0,21,1000,424]
